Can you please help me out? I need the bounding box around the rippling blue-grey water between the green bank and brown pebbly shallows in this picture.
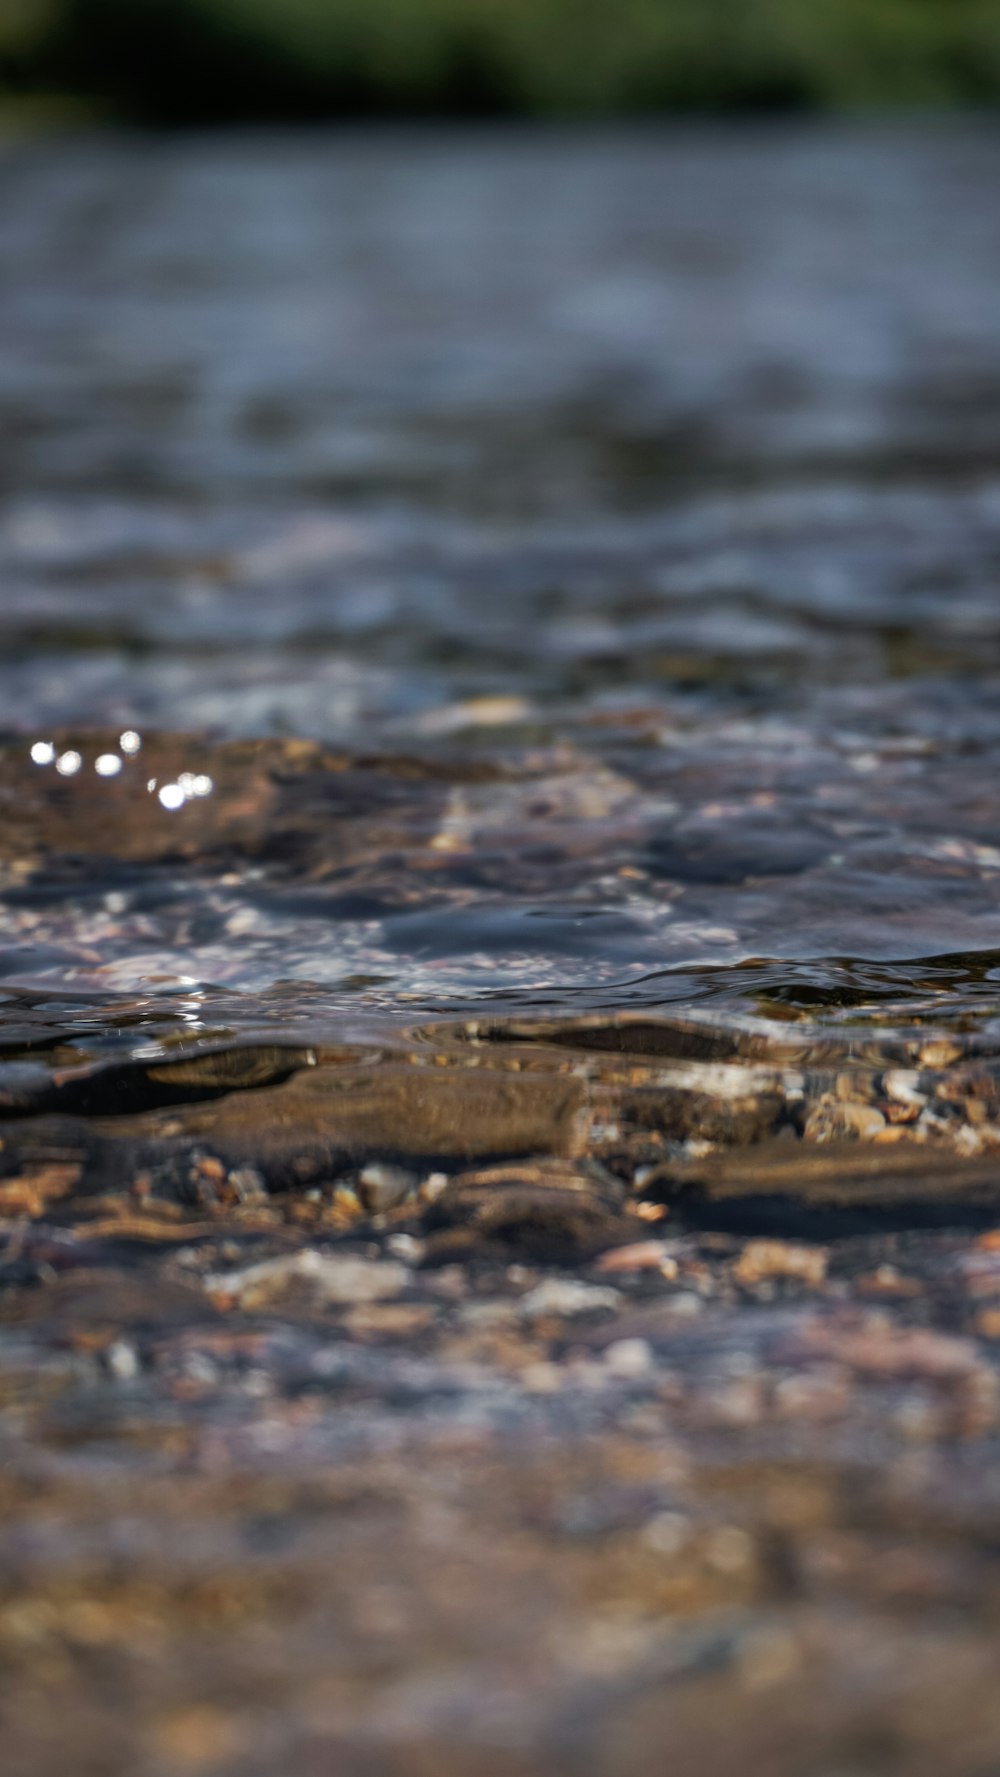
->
[0,130,1000,1036]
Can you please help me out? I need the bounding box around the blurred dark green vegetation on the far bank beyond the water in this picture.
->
[0,0,1000,123]
